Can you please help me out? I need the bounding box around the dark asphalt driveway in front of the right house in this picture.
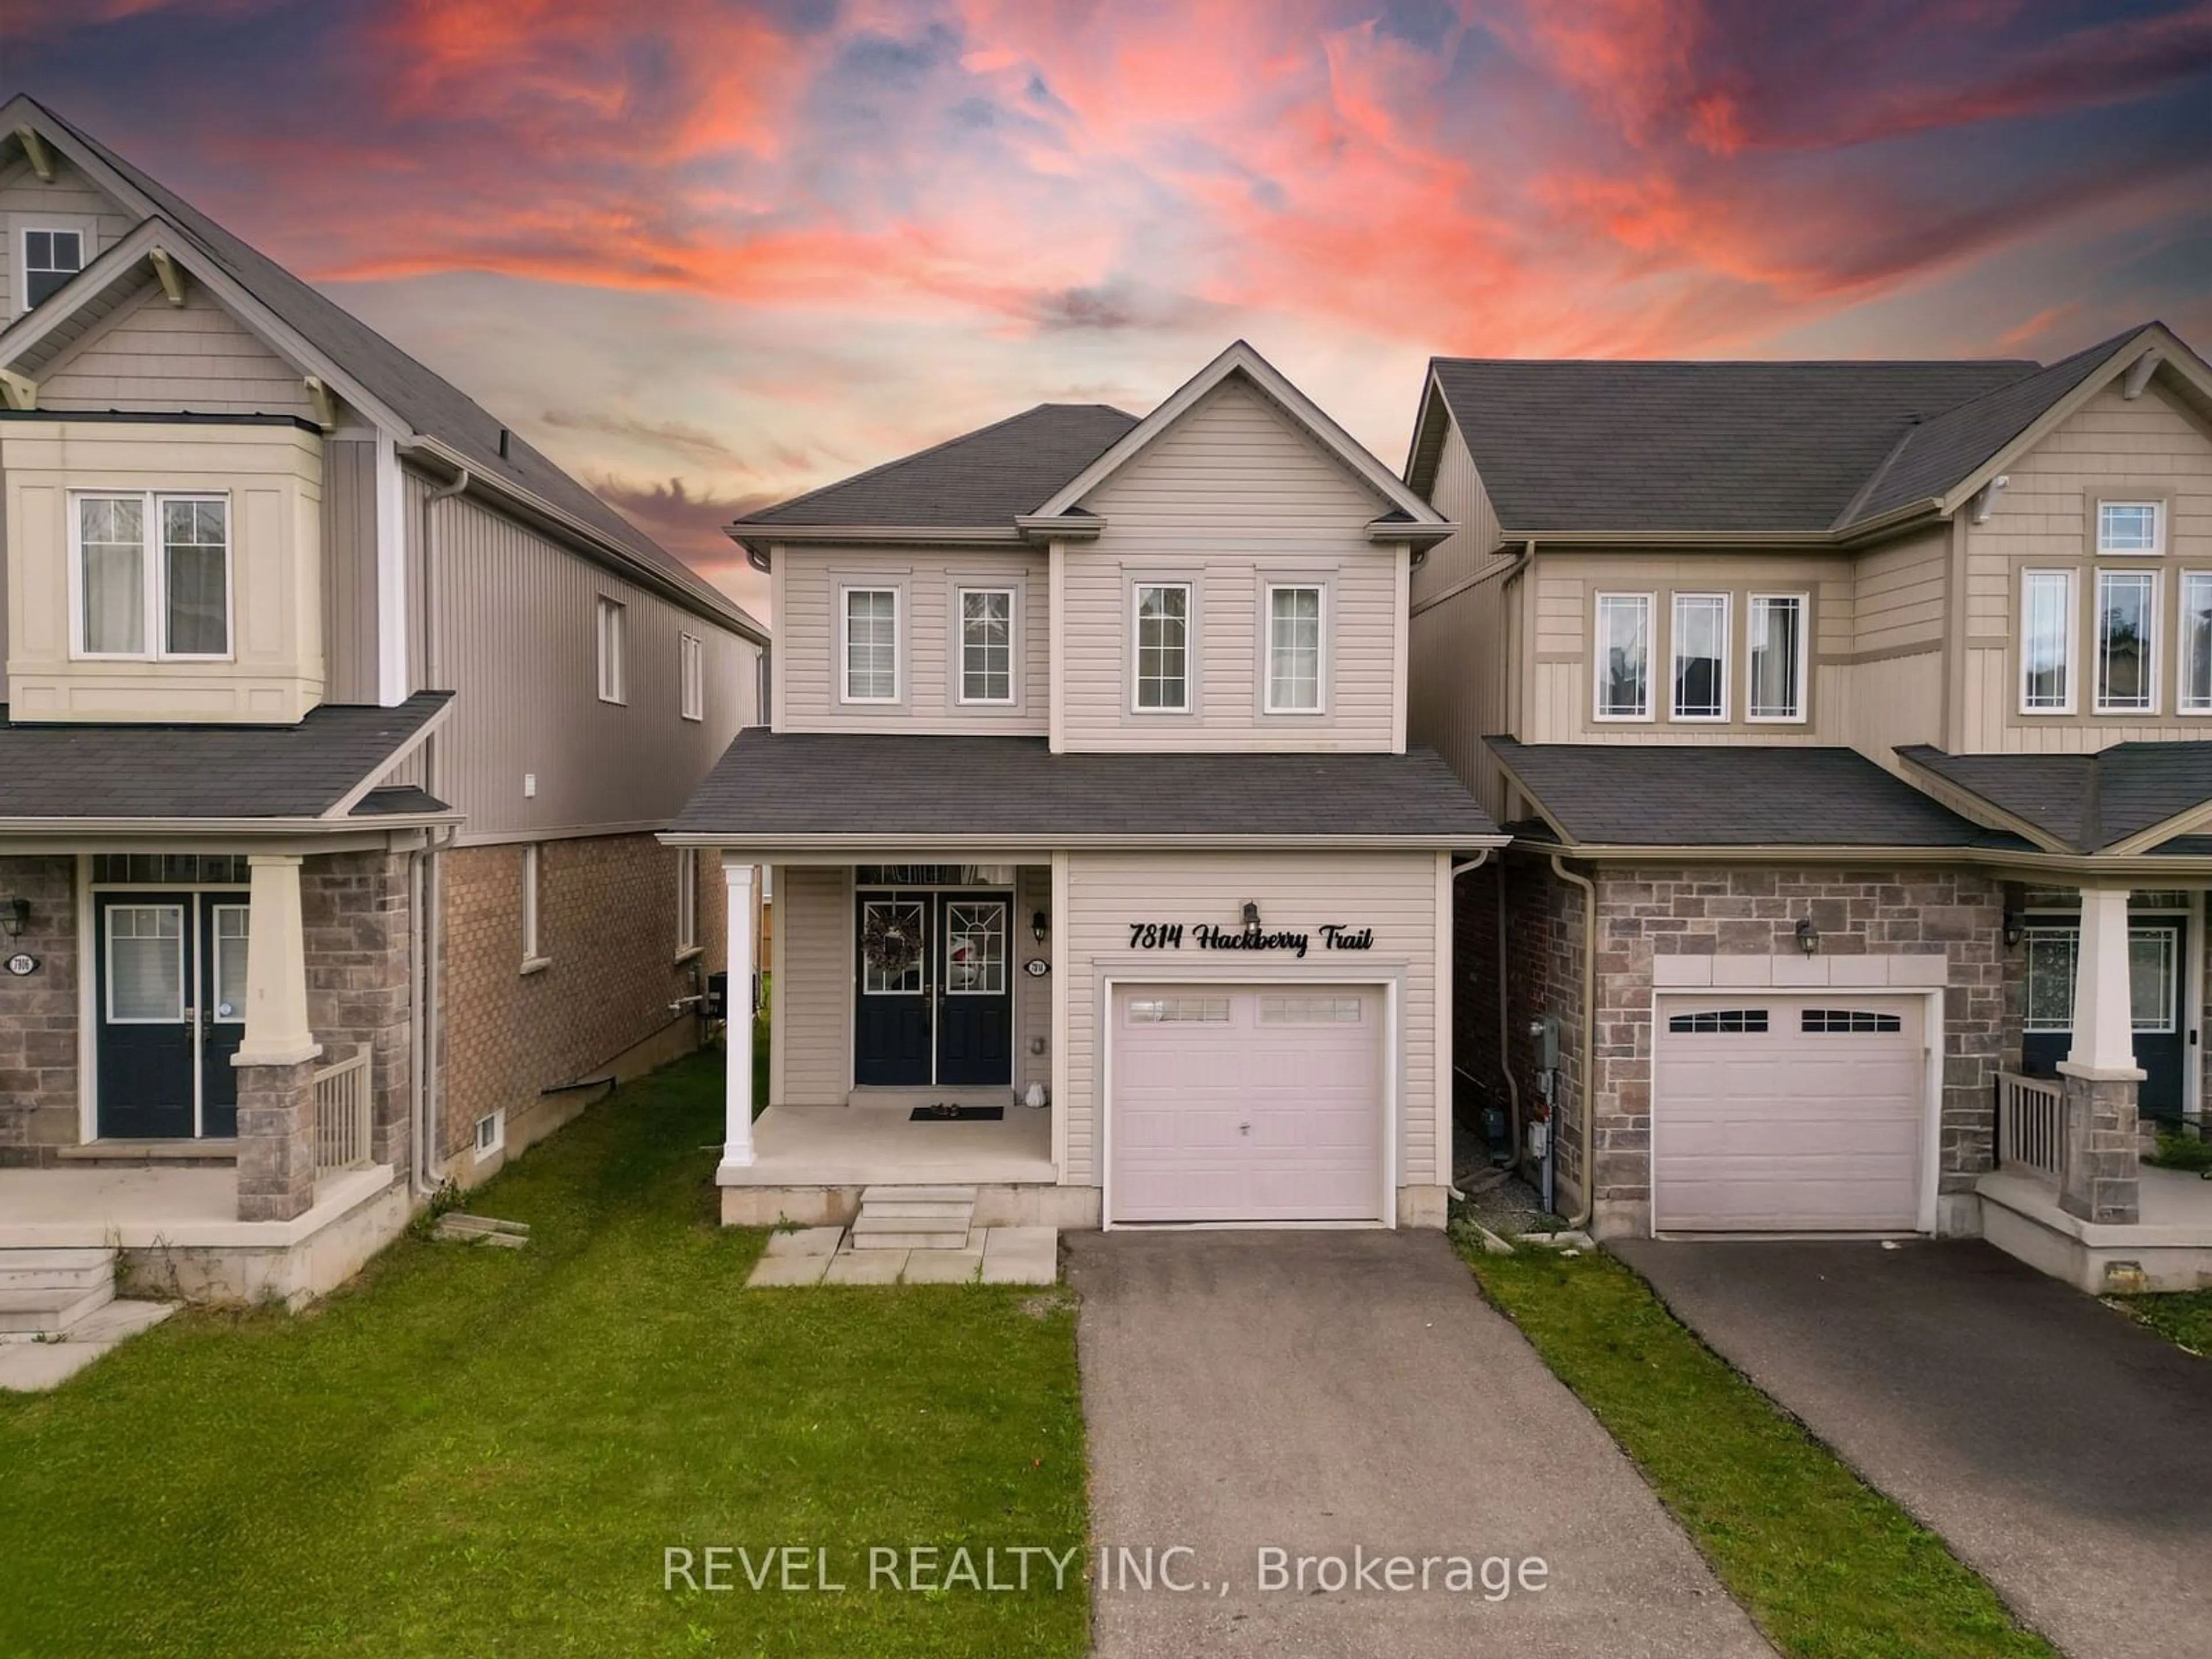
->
[1615,1238,2212,1659]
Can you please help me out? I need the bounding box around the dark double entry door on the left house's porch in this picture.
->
[93,892,248,1141]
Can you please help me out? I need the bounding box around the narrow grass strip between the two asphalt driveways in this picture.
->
[1469,1250,2055,1659]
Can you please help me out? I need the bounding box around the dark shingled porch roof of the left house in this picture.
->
[0,692,451,819]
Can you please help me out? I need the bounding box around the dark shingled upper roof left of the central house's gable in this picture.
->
[732,403,1137,528]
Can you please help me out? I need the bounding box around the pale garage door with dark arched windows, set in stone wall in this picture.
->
[1652,991,1927,1232]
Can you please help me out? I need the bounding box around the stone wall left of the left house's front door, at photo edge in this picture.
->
[0,856,77,1164]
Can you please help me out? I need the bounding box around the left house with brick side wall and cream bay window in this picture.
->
[0,97,766,1294]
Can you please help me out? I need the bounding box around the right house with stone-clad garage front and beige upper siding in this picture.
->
[1407,325,2212,1283]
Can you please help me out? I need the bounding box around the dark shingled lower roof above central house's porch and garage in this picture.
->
[671,726,1498,843]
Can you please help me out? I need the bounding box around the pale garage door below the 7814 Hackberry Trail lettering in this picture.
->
[1106,984,1382,1221]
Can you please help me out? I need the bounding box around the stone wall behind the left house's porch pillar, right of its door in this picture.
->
[298,851,414,1172]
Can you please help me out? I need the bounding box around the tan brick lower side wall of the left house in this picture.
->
[440,836,741,1181]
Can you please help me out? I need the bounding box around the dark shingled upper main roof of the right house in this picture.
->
[1431,343,2139,533]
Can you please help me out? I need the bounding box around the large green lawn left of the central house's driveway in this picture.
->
[0,1058,1088,1659]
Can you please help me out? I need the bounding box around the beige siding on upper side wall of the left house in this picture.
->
[407,489,759,840]
